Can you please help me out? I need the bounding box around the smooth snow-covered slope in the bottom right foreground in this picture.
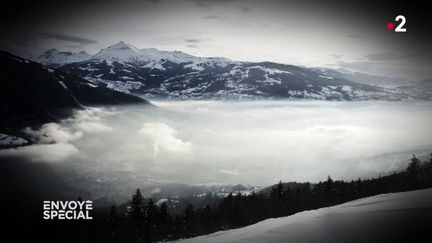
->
[175,189,432,243]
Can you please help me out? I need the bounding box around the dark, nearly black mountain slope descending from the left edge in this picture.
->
[0,52,148,135]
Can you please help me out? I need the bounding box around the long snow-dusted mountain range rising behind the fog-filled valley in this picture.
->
[31,41,428,100]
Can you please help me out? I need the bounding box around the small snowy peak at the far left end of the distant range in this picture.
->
[34,49,91,68]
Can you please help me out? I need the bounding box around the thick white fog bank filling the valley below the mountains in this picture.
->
[0,101,432,186]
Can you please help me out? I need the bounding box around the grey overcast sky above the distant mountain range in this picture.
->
[2,0,432,79]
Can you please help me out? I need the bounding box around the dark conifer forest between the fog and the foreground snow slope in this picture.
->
[9,154,432,242]
